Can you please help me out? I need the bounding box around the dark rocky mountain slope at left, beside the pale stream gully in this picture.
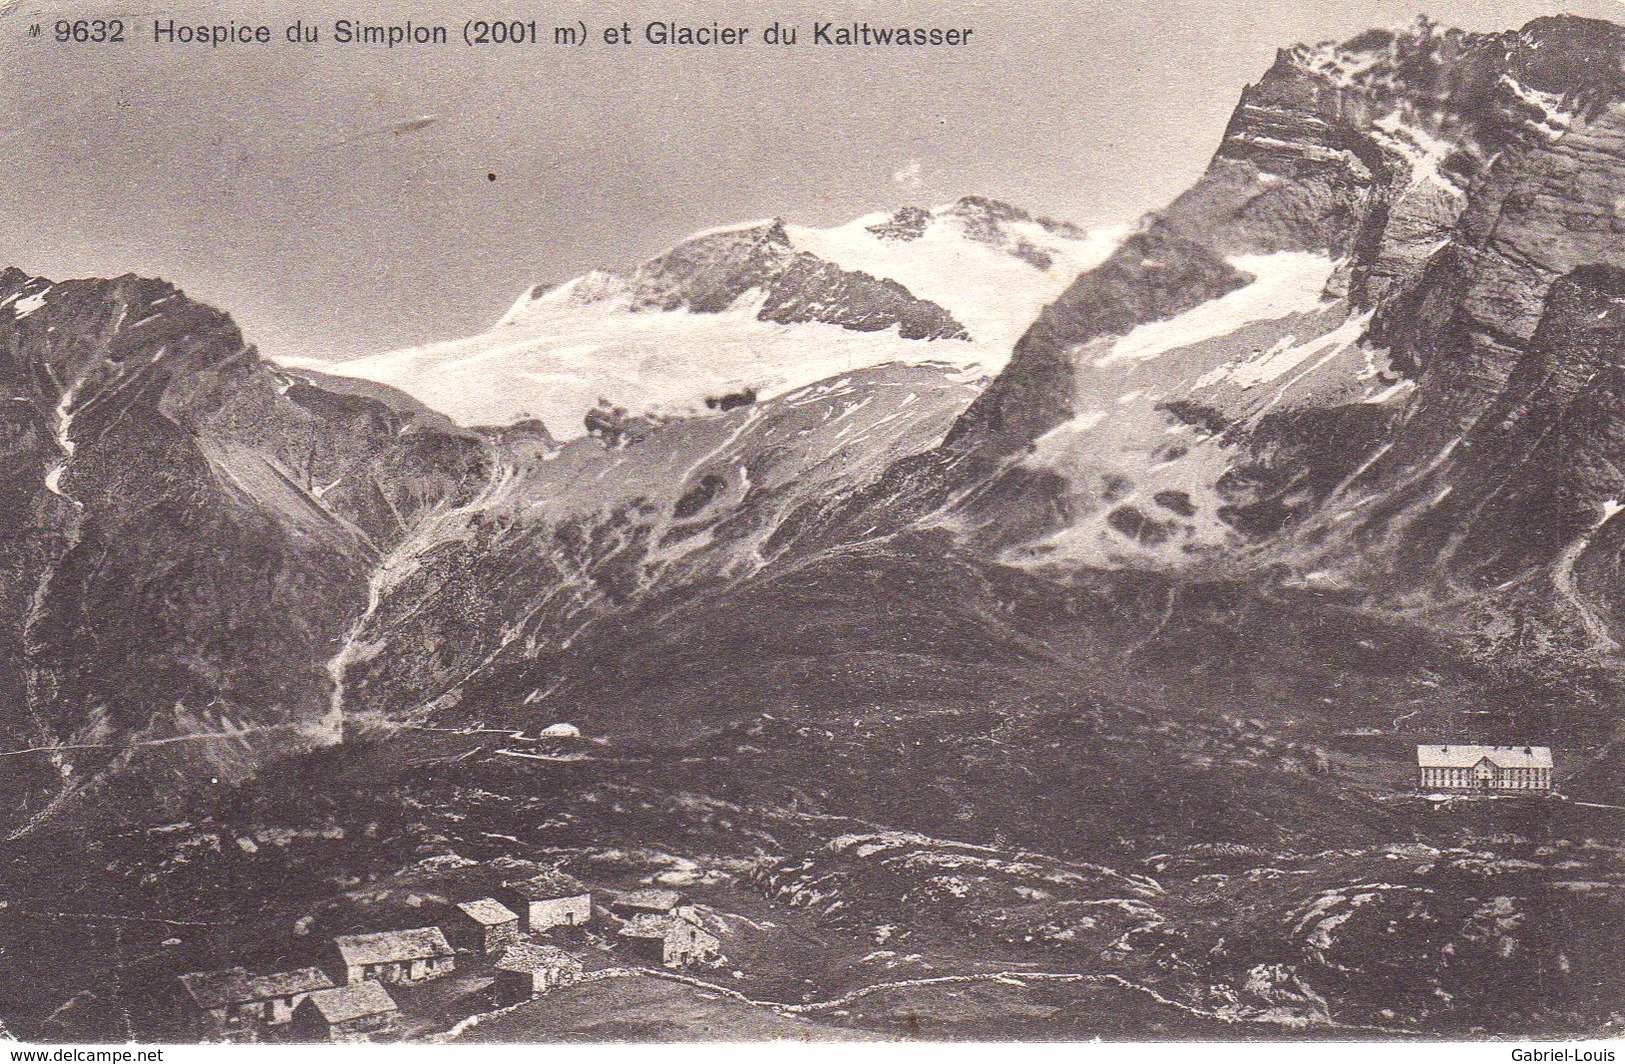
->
[0,270,489,830]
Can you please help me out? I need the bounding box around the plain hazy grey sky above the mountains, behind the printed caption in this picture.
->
[0,0,1625,359]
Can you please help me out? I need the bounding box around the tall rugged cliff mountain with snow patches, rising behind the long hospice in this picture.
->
[947,18,1625,627]
